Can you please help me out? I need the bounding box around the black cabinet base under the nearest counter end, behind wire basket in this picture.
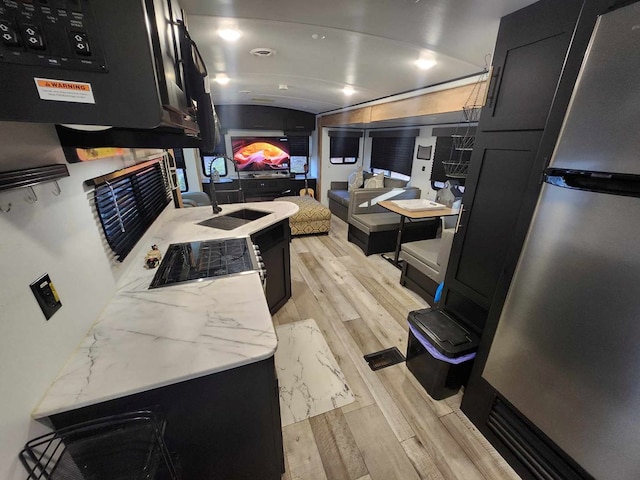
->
[50,357,284,480]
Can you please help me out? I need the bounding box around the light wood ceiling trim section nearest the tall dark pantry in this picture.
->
[371,82,486,122]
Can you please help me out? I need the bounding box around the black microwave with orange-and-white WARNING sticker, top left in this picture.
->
[0,0,216,146]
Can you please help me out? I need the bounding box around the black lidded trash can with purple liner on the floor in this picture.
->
[407,308,479,400]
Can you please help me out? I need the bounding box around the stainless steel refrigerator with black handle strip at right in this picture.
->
[483,4,640,480]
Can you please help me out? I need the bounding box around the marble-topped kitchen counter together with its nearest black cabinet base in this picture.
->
[33,202,297,479]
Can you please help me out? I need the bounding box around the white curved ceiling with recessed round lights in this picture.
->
[180,0,533,113]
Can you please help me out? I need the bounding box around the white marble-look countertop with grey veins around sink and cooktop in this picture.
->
[32,202,298,418]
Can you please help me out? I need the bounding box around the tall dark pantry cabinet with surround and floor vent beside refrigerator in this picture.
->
[440,0,630,479]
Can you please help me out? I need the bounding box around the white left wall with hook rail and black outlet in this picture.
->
[0,122,131,480]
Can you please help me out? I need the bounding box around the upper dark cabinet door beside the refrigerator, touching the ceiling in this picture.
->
[479,0,584,131]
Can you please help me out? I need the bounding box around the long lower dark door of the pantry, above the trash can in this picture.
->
[445,131,542,318]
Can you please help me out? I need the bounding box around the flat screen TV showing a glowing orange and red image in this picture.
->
[231,137,291,172]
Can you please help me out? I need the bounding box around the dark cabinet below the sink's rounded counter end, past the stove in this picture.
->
[251,219,291,314]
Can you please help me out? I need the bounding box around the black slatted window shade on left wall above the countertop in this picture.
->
[94,160,171,262]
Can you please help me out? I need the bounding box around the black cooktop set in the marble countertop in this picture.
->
[149,237,259,288]
